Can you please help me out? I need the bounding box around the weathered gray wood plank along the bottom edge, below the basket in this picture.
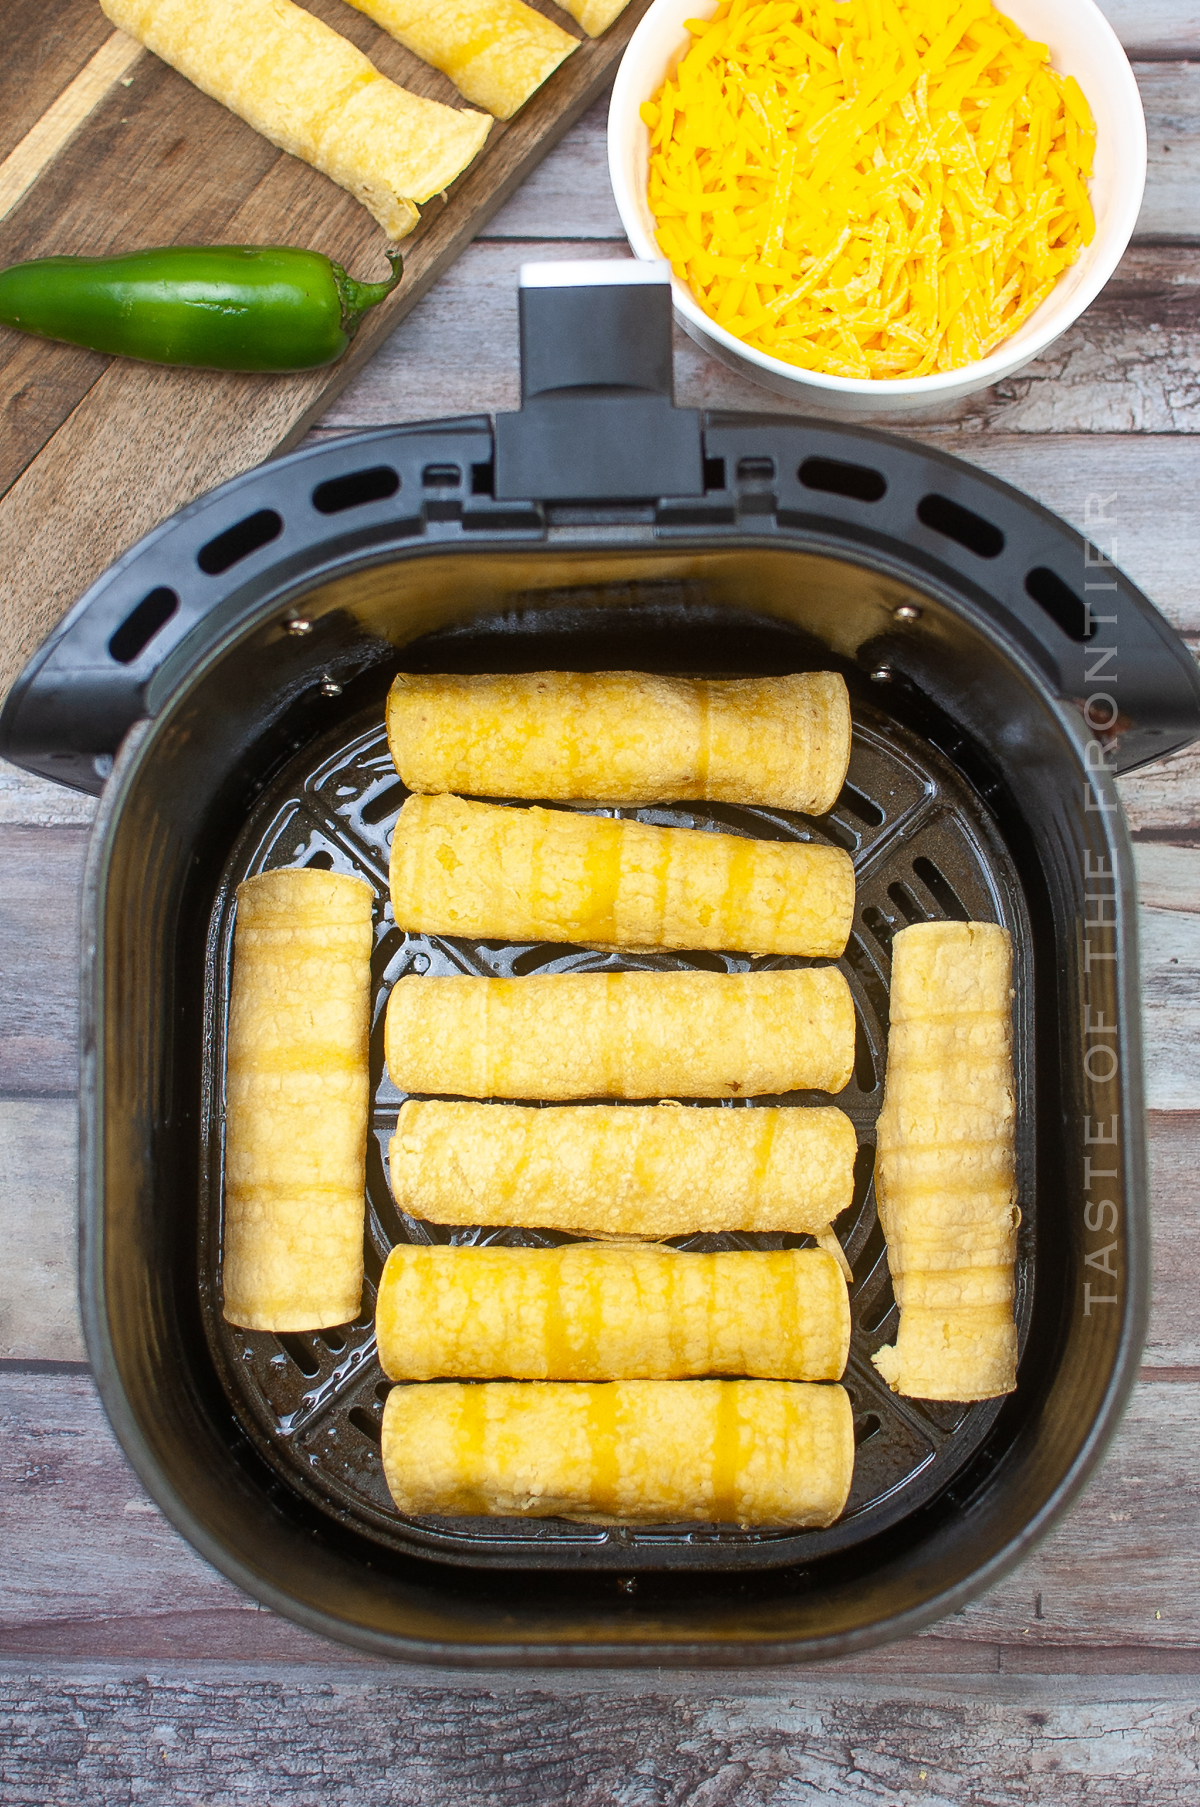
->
[0,1662,1200,1807]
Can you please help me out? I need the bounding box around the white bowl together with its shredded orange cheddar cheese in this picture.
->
[609,0,1146,414]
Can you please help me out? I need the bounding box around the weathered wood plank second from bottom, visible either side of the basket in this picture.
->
[0,1370,1200,1655]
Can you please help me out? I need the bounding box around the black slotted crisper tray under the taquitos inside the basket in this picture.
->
[199,647,1036,1570]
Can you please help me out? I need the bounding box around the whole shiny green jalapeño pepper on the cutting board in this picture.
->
[0,244,403,370]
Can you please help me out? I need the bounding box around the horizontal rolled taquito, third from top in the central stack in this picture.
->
[385,967,855,1099]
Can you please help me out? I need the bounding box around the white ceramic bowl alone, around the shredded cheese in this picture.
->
[609,0,1146,414]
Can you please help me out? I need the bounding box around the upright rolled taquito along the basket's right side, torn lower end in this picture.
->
[873,922,1021,1400]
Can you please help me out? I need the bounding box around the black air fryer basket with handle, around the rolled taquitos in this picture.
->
[0,266,1200,1666]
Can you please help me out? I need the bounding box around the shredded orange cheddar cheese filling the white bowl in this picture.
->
[642,0,1095,378]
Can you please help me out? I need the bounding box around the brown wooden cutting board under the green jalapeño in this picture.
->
[0,0,649,696]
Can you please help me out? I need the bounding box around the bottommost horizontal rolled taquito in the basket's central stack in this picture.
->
[383,1381,855,1525]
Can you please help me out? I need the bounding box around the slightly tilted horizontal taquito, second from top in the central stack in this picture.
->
[392,797,855,958]
